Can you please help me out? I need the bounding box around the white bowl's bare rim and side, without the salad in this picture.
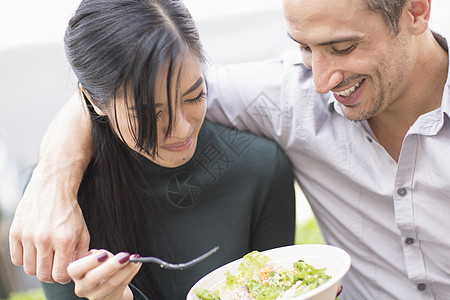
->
[186,245,351,300]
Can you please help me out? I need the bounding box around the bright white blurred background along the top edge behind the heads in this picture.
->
[0,0,450,51]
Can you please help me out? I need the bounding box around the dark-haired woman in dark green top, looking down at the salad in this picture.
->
[44,0,295,299]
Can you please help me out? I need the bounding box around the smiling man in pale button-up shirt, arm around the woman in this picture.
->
[7,0,450,299]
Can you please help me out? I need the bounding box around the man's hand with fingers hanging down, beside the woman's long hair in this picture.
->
[9,165,89,283]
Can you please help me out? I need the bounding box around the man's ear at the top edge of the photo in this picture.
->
[406,0,431,35]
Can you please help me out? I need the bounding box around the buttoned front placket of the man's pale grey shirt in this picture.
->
[393,134,431,299]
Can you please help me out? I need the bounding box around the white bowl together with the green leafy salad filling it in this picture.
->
[187,245,350,300]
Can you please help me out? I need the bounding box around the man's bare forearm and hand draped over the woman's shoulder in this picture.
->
[9,93,92,283]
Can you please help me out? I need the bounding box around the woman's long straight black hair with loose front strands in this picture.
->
[64,0,204,297]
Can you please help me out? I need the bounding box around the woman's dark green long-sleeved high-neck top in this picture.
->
[43,121,295,300]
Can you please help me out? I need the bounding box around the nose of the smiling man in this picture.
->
[311,54,344,94]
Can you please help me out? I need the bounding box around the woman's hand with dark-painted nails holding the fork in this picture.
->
[67,250,142,300]
